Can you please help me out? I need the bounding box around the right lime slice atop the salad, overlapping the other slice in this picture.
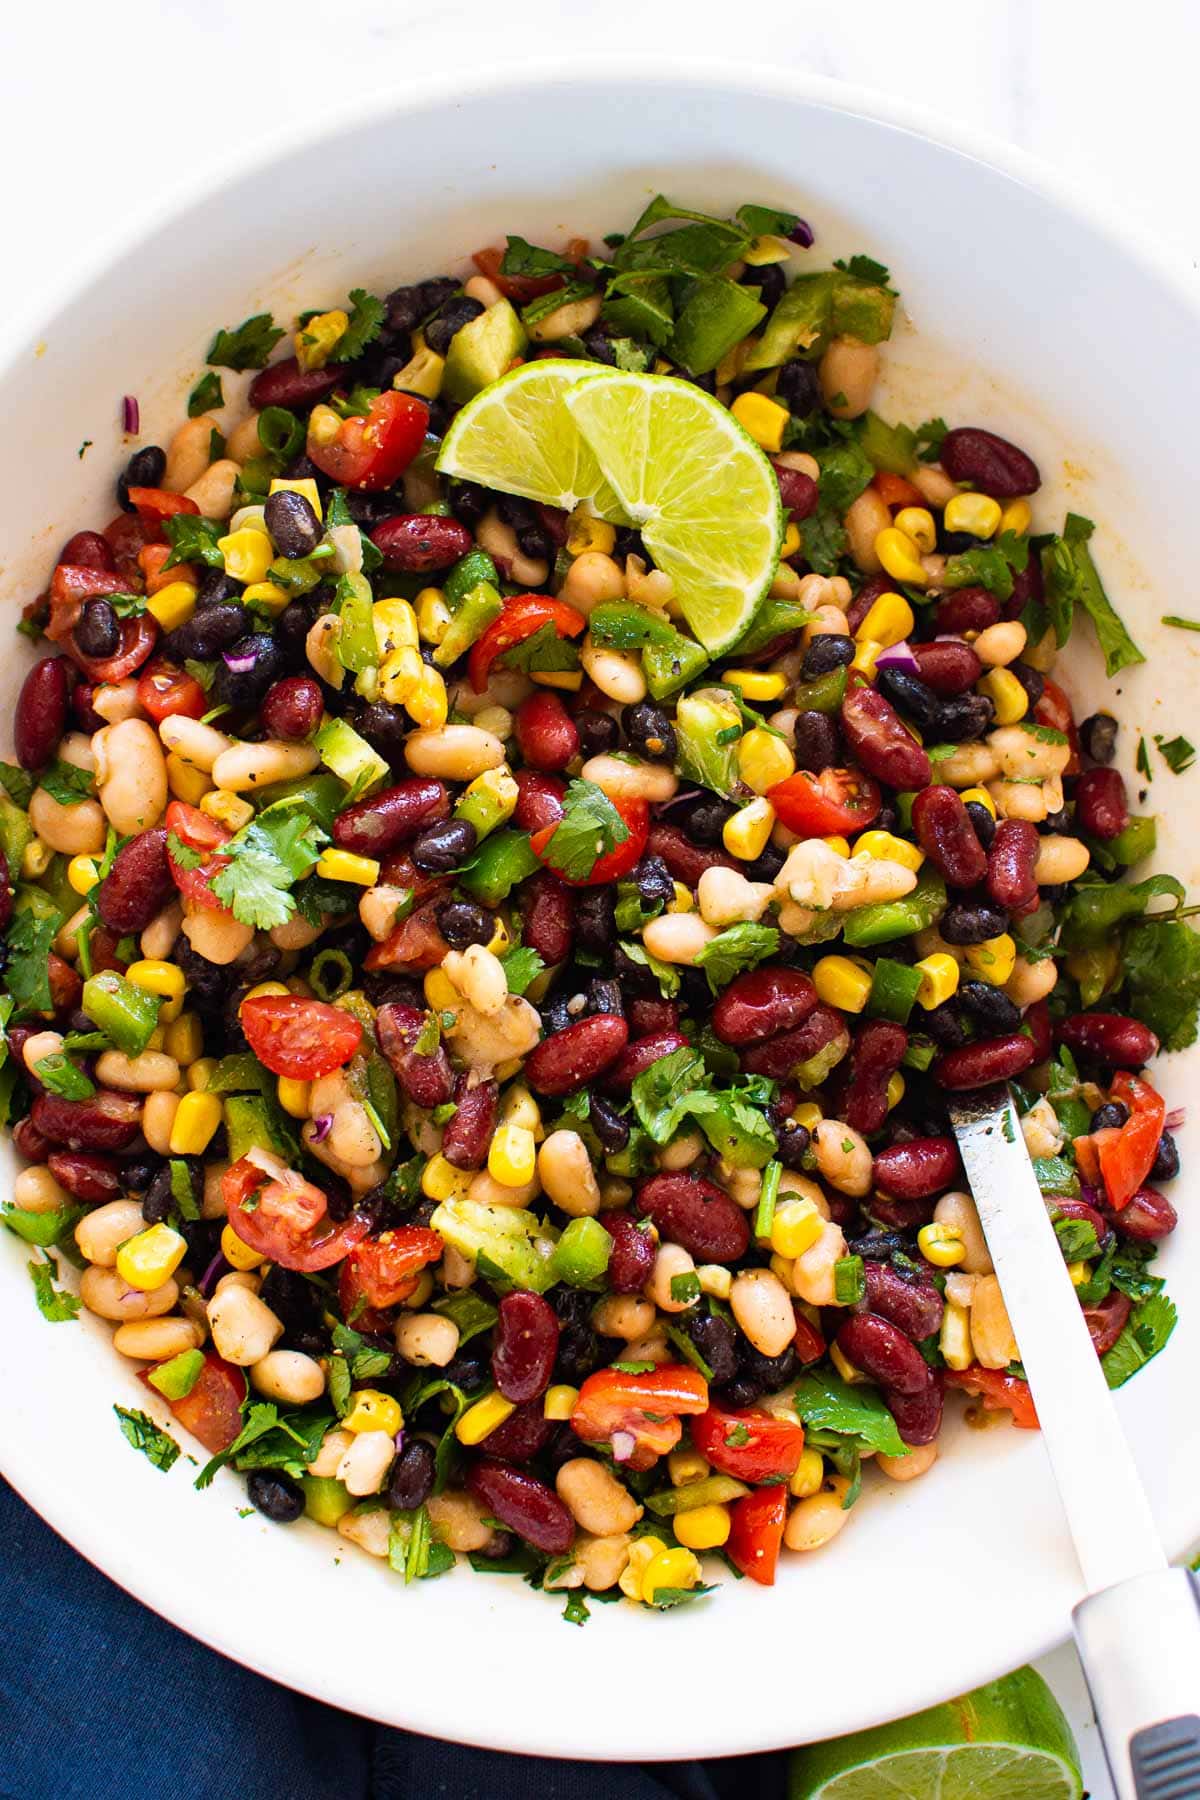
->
[563,369,784,655]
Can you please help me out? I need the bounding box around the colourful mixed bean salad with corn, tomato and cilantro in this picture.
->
[0,200,1200,1624]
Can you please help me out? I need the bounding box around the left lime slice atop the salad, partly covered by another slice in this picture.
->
[437,356,630,526]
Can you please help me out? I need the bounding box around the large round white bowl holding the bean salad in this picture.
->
[0,63,1200,1759]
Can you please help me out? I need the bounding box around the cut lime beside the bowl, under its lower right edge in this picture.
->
[790,1669,1083,1800]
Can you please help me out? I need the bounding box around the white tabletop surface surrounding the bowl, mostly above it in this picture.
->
[9,0,1200,1800]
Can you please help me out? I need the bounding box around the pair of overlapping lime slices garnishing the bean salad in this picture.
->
[437,358,786,655]
